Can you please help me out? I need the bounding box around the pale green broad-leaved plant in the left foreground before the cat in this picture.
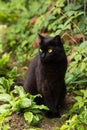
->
[0,78,48,125]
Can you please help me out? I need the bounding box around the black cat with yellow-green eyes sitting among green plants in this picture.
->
[24,35,67,116]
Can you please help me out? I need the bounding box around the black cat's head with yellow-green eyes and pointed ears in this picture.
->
[39,35,64,63]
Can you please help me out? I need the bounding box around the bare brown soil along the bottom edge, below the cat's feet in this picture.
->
[9,113,65,130]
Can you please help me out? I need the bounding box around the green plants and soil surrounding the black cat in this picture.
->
[0,0,87,130]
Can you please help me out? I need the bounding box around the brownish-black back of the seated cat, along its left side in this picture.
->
[24,55,39,94]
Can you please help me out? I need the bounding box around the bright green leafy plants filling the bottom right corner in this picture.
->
[60,90,87,130]
